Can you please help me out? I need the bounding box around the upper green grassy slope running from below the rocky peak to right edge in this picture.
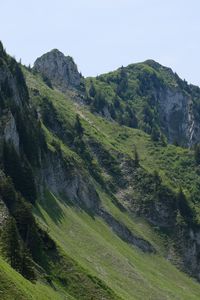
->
[26,67,196,192]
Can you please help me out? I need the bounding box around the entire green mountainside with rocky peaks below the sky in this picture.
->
[0,45,200,300]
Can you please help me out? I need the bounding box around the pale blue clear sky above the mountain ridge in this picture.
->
[0,0,200,85]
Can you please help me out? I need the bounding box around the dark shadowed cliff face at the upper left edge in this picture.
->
[0,48,30,155]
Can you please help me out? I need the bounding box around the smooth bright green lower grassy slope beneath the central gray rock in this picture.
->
[35,190,200,300]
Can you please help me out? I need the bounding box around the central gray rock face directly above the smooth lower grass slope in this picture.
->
[38,154,100,213]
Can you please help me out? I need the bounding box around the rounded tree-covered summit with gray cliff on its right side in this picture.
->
[87,60,200,146]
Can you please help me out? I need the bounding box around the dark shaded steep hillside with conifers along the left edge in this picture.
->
[0,45,120,299]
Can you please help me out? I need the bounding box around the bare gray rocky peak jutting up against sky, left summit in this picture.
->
[34,49,81,92]
